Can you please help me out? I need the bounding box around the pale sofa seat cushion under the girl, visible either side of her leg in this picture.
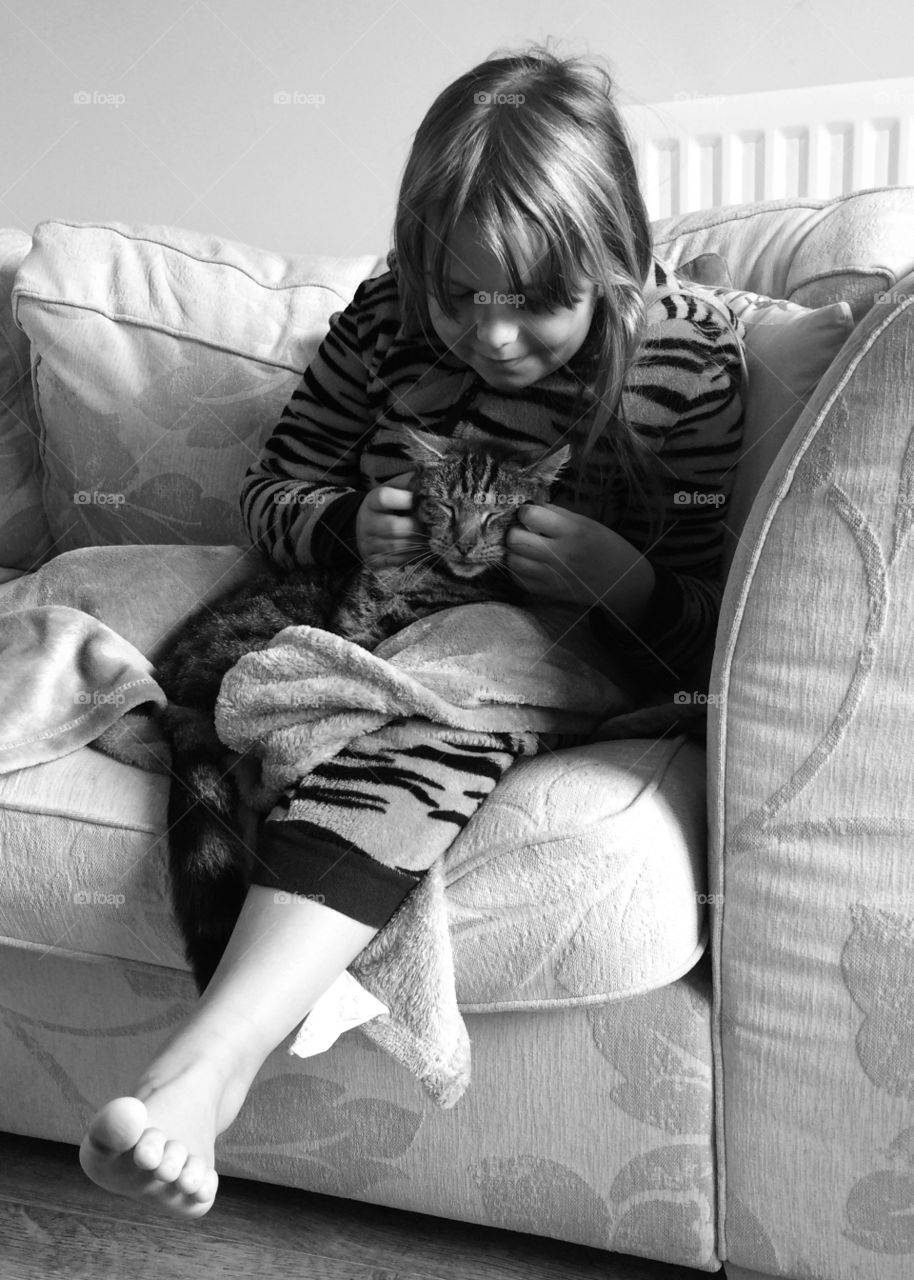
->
[0,739,707,1012]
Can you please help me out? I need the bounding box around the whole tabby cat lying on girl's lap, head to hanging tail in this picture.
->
[156,428,571,991]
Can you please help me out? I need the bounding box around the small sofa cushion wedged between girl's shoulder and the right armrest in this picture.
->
[691,284,854,572]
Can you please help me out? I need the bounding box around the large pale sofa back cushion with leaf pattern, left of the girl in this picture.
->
[14,221,385,550]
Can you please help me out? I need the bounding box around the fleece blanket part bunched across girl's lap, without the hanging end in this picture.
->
[215,603,631,808]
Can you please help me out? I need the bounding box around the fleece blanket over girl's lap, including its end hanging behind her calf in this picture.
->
[216,603,631,1107]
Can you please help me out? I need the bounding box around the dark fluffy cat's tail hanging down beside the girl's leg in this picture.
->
[160,703,253,992]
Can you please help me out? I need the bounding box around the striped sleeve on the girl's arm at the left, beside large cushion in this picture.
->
[241,273,397,568]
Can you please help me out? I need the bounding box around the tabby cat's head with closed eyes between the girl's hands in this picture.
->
[401,433,571,579]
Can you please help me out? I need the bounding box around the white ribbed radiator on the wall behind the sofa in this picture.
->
[622,77,914,219]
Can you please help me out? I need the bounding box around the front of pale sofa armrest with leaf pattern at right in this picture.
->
[709,275,914,1280]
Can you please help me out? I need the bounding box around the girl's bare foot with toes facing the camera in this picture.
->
[79,1042,251,1219]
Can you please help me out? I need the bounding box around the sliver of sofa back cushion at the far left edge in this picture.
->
[0,229,51,570]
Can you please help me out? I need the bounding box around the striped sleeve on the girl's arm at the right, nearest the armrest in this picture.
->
[593,285,745,694]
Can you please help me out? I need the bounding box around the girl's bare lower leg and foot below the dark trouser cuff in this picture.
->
[79,884,376,1217]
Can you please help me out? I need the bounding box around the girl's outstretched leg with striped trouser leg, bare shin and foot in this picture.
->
[79,728,536,1217]
